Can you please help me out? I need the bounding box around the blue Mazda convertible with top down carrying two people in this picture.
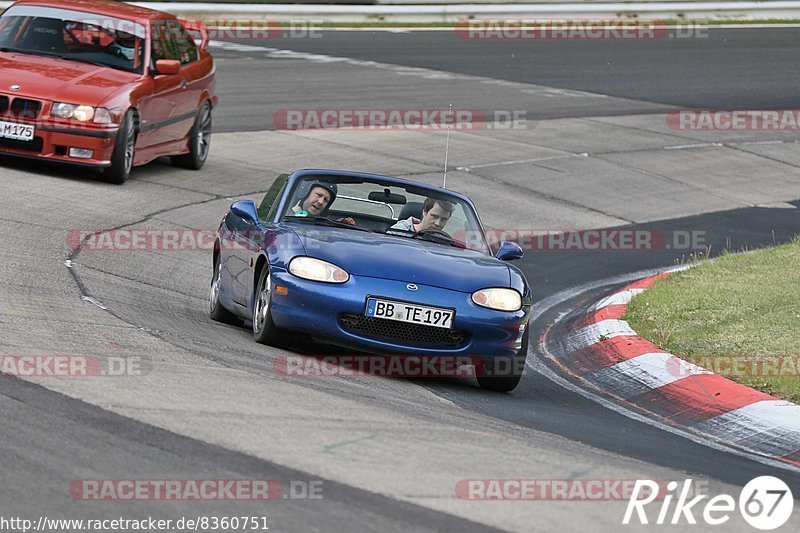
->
[210,170,531,391]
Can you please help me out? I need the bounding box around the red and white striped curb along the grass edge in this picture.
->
[553,273,800,466]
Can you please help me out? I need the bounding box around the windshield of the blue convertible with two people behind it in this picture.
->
[283,176,491,253]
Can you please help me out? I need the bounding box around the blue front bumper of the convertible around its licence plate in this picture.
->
[271,268,530,358]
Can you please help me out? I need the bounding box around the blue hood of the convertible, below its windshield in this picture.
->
[291,224,511,293]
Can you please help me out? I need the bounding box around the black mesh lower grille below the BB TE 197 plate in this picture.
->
[341,314,467,348]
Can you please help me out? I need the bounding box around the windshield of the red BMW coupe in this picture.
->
[0,6,146,74]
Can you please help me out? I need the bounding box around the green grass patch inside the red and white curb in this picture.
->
[624,240,800,403]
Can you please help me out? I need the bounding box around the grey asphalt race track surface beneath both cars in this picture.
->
[0,29,800,531]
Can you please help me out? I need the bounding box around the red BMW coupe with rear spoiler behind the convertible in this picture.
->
[0,0,217,183]
